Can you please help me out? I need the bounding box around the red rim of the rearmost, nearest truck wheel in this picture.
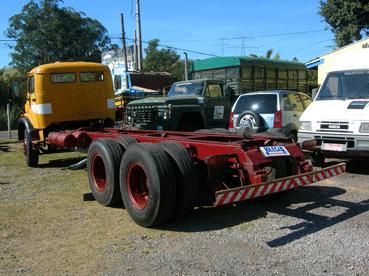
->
[127,163,149,209]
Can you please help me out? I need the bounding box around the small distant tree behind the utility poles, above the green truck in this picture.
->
[143,38,184,78]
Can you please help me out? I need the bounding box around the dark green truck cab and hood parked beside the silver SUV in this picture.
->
[125,80,232,131]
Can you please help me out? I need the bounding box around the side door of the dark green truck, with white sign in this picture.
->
[204,82,231,128]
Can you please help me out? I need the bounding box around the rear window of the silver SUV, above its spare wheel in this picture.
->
[234,94,277,114]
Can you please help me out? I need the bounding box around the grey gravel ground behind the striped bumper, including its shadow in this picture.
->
[112,163,369,275]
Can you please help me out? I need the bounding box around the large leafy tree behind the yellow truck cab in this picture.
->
[6,0,110,73]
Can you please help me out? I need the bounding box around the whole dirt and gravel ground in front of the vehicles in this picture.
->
[0,140,369,275]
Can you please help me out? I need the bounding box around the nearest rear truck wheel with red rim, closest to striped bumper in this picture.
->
[120,143,176,227]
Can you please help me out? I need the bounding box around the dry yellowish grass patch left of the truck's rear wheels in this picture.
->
[0,140,184,274]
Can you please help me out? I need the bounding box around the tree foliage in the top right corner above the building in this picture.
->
[319,0,369,47]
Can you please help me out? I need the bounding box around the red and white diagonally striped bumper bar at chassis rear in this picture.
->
[214,163,346,206]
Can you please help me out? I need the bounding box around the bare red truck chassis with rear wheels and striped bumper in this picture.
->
[41,128,345,227]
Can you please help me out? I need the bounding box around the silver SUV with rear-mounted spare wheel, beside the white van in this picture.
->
[229,90,312,141]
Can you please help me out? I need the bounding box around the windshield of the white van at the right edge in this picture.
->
[316,70,369,100]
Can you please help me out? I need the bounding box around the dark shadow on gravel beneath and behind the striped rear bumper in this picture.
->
[162,183,369,247]
